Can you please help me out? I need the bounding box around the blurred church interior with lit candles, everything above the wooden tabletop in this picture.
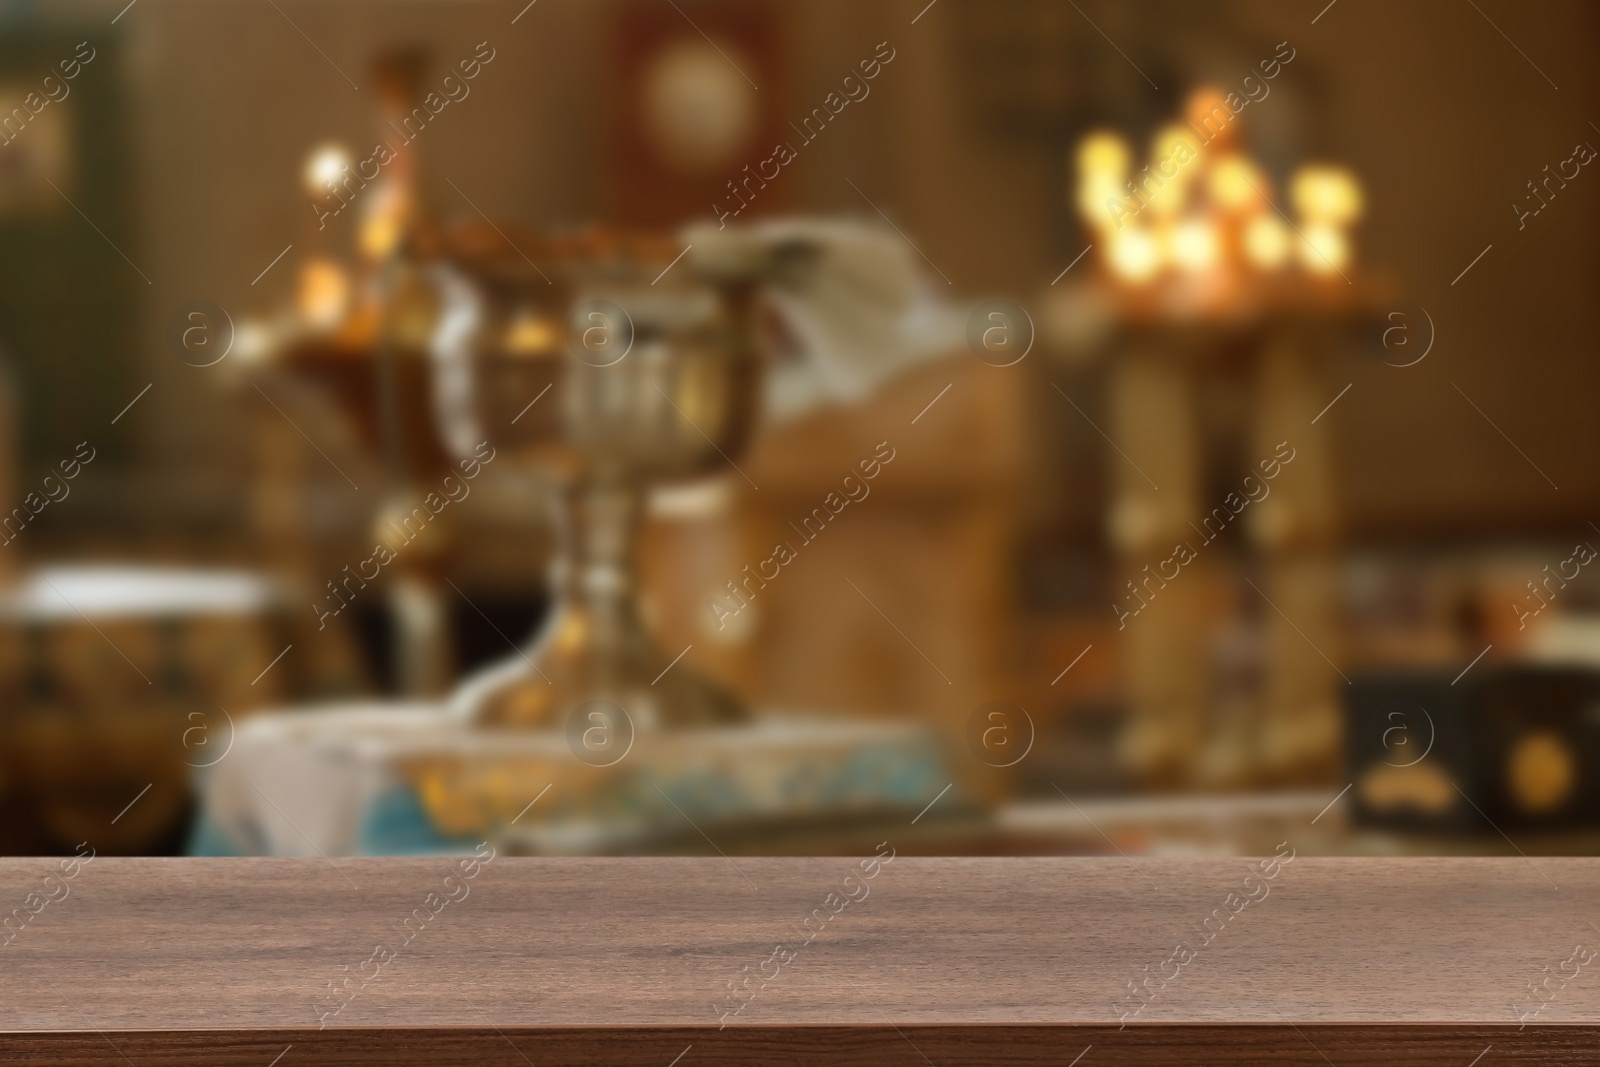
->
[0,0,1600,856]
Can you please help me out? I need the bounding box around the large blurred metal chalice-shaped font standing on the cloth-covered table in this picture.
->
[434,231,762,736]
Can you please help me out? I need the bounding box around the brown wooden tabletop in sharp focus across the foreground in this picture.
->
[0,846,1600,1067]
